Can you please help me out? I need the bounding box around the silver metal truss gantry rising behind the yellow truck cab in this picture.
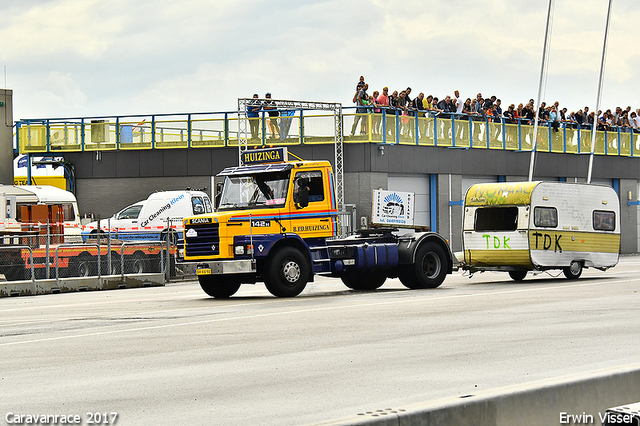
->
[238,98,344,212]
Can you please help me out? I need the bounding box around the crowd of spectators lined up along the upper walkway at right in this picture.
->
[351,76,640,135]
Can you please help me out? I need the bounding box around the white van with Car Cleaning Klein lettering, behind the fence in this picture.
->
[82,190,213,242]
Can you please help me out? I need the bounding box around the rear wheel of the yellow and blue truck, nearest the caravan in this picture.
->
[398,242,447,289]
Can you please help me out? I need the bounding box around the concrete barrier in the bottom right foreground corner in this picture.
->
[320,364,640,426]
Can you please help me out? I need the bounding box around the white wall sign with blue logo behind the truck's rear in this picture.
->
[371,190,415,226]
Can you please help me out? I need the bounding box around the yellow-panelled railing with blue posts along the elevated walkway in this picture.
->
[16,108,640,157]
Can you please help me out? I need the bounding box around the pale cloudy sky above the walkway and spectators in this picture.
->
[0,0,640,120]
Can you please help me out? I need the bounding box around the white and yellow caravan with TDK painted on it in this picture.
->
[456,182,620,281]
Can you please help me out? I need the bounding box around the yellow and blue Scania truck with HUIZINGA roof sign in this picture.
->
[184,148,453,298]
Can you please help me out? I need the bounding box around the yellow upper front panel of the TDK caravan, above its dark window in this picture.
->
[464,182,540,206]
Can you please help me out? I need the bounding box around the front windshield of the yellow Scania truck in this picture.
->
[218,171,289,210]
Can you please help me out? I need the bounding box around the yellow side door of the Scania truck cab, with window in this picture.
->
[288,170,335,238]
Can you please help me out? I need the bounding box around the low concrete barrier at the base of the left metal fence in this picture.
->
[0,273,164,297]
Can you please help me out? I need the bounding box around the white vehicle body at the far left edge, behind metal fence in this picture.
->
[0,185,82,242]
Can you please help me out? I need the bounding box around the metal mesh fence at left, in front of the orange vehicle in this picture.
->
[0,231,171,281]
